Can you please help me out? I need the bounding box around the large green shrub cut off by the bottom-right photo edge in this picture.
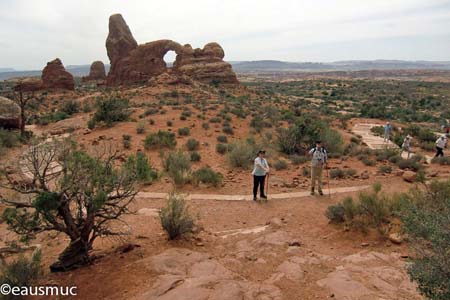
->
[401,181,450,300]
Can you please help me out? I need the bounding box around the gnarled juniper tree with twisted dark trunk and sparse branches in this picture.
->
[0,141,136,271]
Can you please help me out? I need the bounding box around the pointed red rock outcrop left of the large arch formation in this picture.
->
[42,58,75,90]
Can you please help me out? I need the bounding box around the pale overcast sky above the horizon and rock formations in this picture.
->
[0,0,450,69]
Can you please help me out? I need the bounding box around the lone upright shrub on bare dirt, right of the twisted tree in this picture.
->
[159,193,194,240]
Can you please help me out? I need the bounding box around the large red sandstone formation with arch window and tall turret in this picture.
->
[106,14,239,86]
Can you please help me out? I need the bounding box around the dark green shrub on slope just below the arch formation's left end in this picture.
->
[91,96,130,127]
